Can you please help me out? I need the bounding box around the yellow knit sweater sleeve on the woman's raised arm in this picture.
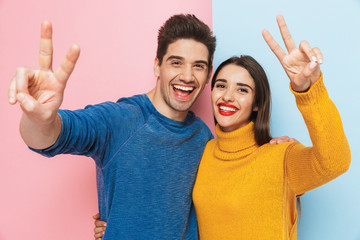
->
[285,74,351,195]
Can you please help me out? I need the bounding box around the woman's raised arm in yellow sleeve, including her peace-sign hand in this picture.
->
[263,16,351,195]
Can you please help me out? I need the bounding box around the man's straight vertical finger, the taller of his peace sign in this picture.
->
[39,21,53,71]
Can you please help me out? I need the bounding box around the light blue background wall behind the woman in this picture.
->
[213,0,360,240]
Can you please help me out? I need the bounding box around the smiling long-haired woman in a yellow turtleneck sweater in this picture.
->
[91,16,350,240]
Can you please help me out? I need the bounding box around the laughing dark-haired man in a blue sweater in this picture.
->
[9,15,215,240]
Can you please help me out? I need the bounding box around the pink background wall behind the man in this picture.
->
[0,0,213,240]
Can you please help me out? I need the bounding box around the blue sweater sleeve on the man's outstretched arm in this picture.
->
[30,102,141,166]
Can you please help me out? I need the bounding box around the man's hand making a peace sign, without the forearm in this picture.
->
[8,21,80,124]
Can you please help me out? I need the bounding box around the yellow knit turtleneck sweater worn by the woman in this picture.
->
[193,77,350,240]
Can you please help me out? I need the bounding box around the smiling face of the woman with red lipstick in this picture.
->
[211,64,257,132]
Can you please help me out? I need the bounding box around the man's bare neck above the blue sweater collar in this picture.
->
[146,87,189,121]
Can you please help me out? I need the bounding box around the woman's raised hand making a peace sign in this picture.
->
[262,15,323,92]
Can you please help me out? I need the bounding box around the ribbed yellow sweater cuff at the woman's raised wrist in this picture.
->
[290,72,328,105]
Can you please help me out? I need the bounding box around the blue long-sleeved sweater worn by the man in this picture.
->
[31,94,212,240]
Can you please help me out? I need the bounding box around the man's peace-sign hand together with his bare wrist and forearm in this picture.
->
[8,21,80,149]
